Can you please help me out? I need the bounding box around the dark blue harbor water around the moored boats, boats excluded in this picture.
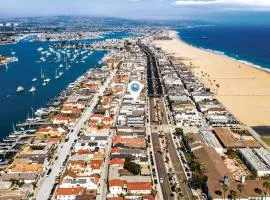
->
[0,32,134,139]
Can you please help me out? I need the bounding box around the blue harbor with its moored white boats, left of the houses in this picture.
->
[0,32,134,147]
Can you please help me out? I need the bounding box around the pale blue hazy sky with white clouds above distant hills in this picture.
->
[0,0,270,24]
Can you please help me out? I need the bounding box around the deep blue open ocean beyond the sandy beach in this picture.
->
[178,25,270,70]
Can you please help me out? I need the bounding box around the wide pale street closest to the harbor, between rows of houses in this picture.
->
[36,69,116,200]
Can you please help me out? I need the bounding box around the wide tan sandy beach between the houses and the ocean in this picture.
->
[154,31,270,129]
